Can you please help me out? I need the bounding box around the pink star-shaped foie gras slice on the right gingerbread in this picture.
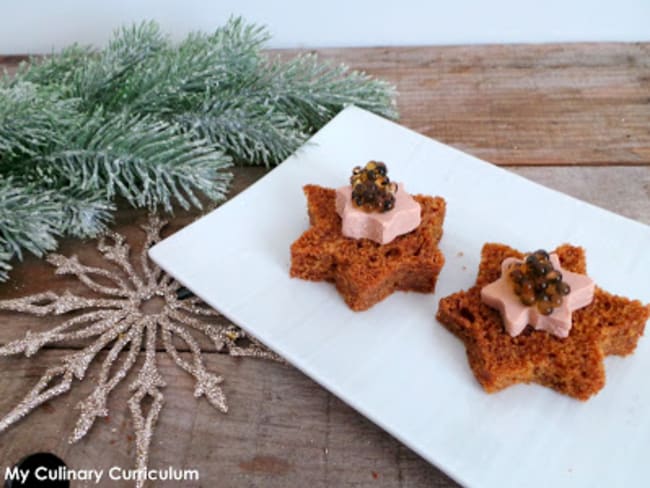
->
[481,254,595,338]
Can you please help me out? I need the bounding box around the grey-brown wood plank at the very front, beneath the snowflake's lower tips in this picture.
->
[0,351,456,488]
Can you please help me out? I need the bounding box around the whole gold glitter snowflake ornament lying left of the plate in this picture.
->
[0,216,279,486]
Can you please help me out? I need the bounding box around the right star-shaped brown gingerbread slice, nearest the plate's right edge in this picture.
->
[437,244,650,400]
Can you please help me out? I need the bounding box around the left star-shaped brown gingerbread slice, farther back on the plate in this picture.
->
[290,185,445,311]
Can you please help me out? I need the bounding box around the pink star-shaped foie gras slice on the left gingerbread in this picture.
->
[336,183,422,244]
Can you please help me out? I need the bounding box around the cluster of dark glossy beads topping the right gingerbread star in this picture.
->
[509,249,571,315]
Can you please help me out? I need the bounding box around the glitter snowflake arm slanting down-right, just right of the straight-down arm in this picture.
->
[160,319,228,413]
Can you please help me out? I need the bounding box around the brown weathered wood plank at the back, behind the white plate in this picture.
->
[5,43,650,165]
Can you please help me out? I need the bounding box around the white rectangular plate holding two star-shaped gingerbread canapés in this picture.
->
[150,107,650,487]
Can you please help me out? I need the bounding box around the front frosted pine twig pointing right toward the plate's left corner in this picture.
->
[33,113,231,211]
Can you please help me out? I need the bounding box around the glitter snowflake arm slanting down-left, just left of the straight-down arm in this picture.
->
[69,324,142,443]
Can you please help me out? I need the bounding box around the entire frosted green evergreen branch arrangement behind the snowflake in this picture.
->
[0,18,397,280]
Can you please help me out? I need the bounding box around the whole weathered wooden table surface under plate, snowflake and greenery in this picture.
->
[0,44,650,488]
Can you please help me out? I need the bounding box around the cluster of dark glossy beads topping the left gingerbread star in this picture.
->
[350,161,397,212]
